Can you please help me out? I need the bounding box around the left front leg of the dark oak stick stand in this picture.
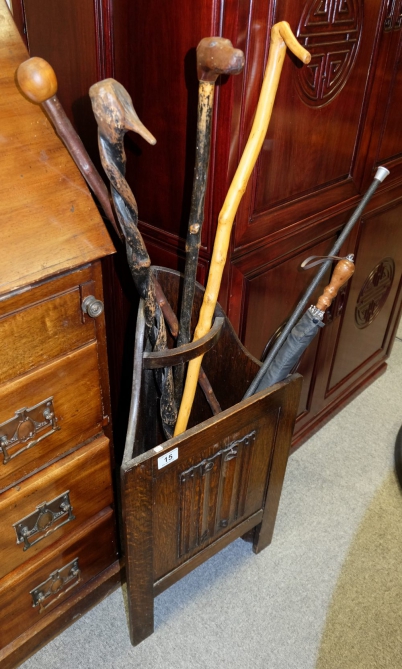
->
[121,461,154,646]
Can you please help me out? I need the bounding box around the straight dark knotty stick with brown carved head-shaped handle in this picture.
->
[174,37,244,404]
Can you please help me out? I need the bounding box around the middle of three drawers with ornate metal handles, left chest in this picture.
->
[0,437,113,578]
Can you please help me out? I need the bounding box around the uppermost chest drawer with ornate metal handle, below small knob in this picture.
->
[0,342,103,491]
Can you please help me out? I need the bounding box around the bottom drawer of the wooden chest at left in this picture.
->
[0,509,116,648]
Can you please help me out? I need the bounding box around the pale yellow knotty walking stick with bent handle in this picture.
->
[175,21,311,435]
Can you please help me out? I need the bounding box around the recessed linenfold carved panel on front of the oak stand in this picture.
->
[178,430,256,557]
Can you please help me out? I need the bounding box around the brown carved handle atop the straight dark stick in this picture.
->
[197,37,244,83]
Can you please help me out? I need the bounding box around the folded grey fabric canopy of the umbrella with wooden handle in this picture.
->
[254,306,325,393]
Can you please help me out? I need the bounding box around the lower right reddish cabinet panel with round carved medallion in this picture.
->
[317,197,402,396]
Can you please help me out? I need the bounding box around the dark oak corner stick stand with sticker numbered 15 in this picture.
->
[121,268,302,645]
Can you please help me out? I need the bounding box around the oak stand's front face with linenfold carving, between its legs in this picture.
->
[150,408,286,580]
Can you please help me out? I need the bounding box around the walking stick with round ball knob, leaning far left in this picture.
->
[17,57,179,337]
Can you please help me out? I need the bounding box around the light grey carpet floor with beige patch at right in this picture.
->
[22,340,402,669]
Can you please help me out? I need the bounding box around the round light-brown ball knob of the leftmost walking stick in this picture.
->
[17,57,57,104]
